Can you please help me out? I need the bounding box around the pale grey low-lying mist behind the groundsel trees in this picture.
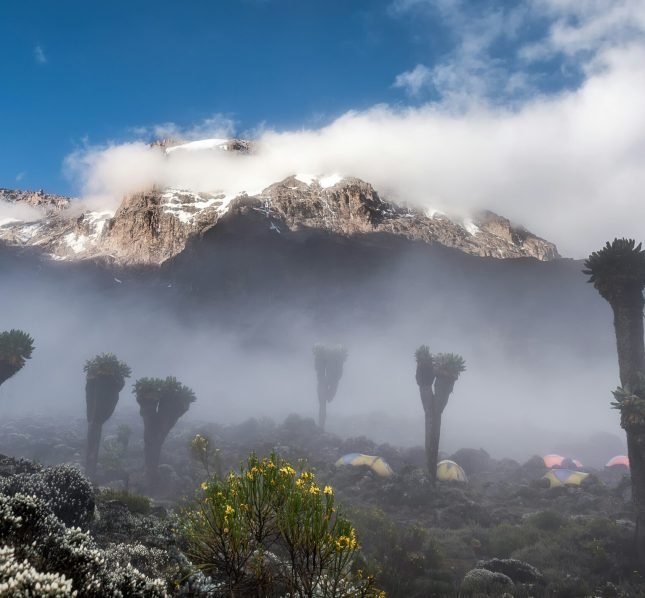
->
[0,241,622,463]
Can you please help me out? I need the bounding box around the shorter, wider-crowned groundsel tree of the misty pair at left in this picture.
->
[133,376,196,492]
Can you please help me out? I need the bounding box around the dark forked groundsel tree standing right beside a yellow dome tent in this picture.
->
[415,345,466,484]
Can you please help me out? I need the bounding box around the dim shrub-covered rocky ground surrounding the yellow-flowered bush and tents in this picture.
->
[0,416,645,597]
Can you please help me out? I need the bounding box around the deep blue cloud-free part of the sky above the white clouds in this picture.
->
[0,0,578,193]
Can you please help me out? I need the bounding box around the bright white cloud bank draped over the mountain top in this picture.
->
[65,0,645,257]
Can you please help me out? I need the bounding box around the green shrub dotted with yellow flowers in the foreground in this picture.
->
[181,454,379,598]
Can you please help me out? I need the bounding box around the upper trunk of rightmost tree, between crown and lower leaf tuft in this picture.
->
[612,300,645,390]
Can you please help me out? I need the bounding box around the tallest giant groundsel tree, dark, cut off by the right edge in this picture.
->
[583,239,645,562]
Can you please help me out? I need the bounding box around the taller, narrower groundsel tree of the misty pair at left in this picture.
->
[83,353,132,478]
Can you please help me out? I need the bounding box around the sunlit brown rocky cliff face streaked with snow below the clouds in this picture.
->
[0,173,559,264]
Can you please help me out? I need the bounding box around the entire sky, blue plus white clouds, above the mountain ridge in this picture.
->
[0,0,645,256]
